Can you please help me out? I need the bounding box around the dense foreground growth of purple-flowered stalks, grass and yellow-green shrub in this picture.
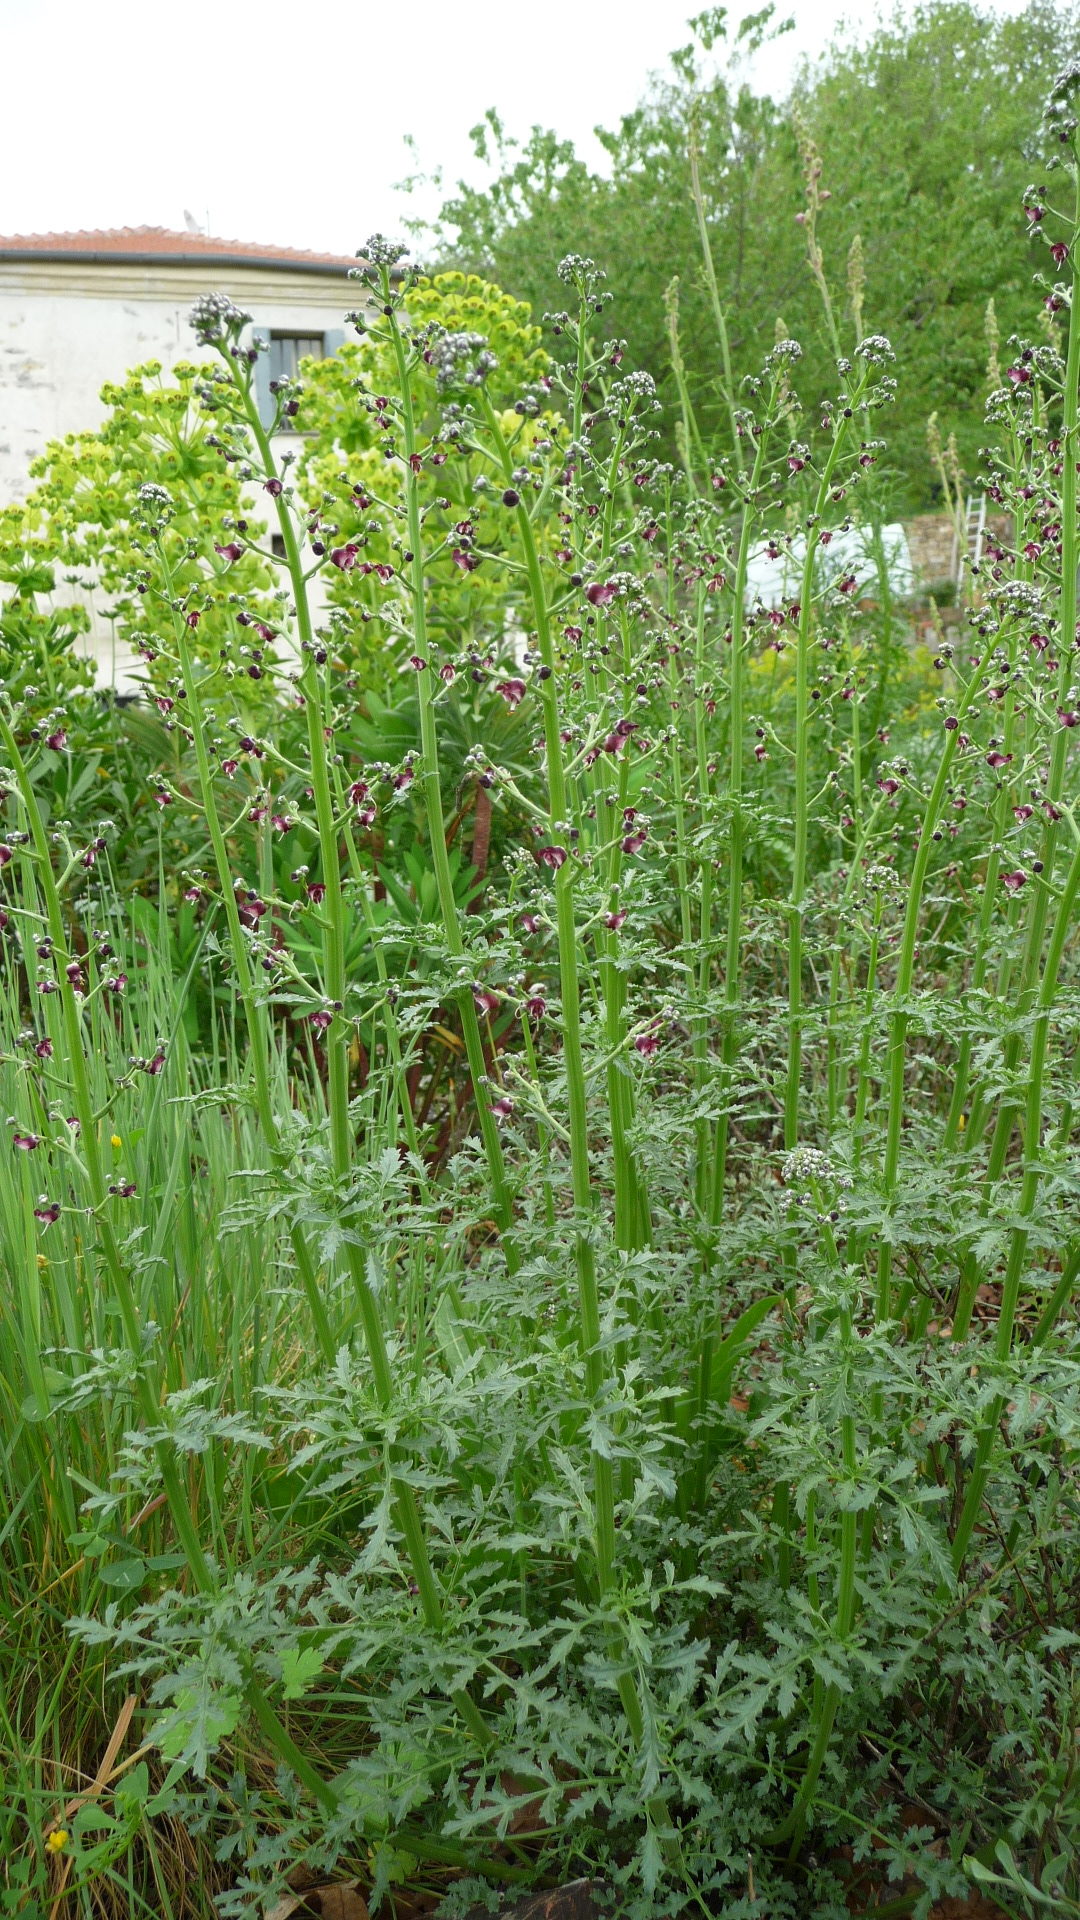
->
[0,73,1080,1920]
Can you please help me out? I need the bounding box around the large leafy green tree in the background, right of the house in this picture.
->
[426,0,1080,511]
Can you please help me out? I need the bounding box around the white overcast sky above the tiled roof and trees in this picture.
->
[0,0,1022,253]
